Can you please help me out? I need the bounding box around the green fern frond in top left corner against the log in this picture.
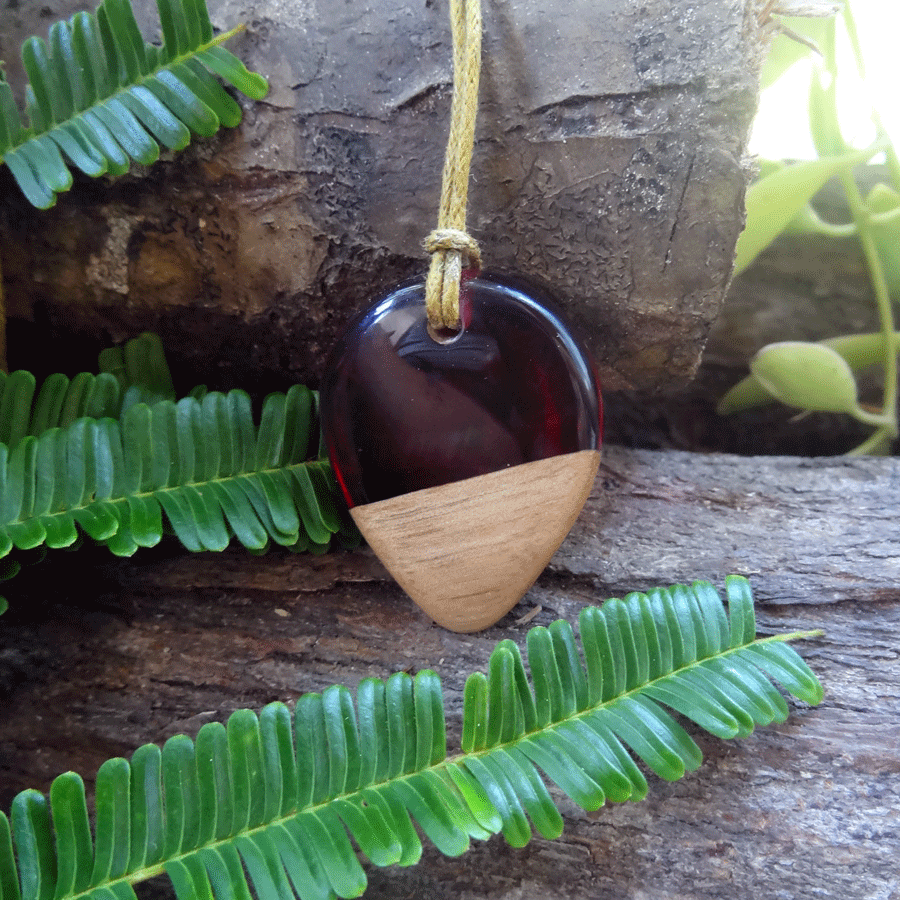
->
[0,0,268,209]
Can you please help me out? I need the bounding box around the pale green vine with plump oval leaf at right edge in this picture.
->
[719,0,900,454]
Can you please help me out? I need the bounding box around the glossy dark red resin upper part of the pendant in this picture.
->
[321,275,602,507]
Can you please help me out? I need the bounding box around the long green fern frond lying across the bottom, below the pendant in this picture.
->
[0,576,822,900]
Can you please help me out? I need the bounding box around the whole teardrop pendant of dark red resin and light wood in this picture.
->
[321,274,602,632]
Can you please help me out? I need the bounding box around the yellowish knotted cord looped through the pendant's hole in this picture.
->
[425,0,481,331]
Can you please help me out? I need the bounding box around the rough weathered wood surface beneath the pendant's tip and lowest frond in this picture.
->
[0,448,900,900]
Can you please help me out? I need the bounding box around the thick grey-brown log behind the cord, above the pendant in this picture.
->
[0,0,763,390]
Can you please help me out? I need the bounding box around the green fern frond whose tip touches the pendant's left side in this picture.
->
[0,384,345,556]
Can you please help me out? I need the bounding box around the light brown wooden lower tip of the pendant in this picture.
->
[351,450,600,632]
